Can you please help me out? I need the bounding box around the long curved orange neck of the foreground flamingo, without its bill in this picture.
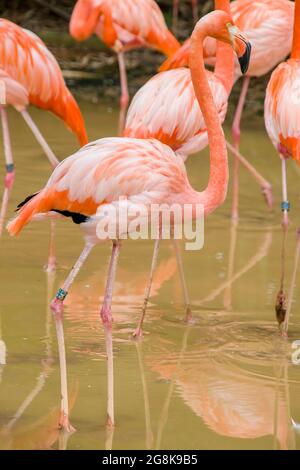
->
[190,12,228,214]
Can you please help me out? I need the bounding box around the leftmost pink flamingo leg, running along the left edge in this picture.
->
[0,106,15,236]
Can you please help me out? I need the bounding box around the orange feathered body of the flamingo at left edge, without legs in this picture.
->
[0,19,88,145]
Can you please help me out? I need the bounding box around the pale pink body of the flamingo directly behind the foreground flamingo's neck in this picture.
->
[124,68,228,155]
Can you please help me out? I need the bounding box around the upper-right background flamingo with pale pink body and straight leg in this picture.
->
[160,0,295,219]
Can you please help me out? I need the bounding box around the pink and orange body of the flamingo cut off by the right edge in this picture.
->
[265,59,300,163]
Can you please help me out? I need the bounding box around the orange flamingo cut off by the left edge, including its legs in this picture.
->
[0,19,88,270]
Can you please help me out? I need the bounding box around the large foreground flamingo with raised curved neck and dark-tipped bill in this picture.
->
[7,11,250,431]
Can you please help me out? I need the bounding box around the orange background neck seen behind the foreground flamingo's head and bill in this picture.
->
[215,0,234,96]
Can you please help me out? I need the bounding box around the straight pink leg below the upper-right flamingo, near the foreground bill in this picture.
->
[231,76,250,219]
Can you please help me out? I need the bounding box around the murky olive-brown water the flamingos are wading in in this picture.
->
[0,104,300,449]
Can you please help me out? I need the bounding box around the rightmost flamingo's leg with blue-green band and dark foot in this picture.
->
[275,156,290,325]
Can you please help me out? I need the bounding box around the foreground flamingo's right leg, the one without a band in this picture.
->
[100,241,121,428]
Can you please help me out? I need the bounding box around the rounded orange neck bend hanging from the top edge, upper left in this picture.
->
[70,0,103,41]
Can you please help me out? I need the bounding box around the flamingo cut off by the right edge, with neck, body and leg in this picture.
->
[265,0,300,334]
